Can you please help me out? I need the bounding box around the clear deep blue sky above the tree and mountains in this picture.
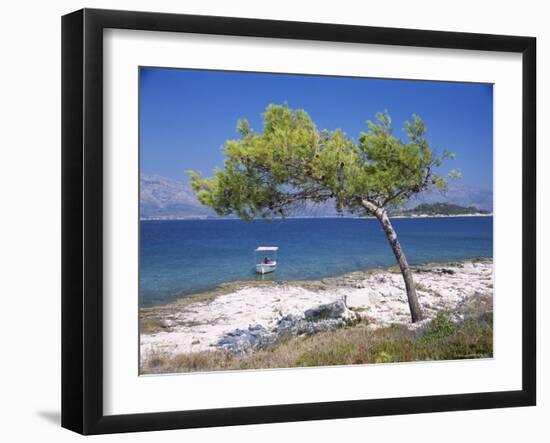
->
[140,68,493,190]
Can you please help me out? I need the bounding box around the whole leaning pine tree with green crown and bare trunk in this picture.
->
[188,105,460,322]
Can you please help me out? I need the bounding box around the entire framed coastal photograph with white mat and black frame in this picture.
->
[62,9,536,434]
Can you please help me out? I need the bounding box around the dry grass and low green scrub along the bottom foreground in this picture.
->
[141,297,493,374]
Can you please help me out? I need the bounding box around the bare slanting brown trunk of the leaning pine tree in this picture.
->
[363,200,424,323]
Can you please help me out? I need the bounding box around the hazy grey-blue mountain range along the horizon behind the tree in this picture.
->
[140,175,493,220]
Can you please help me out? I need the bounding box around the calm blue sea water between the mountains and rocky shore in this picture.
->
[140,217,493,305]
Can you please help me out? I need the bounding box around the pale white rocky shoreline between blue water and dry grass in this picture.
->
[140,259,493,359]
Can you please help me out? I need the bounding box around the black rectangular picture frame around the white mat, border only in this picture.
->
[62,9,536,434]
